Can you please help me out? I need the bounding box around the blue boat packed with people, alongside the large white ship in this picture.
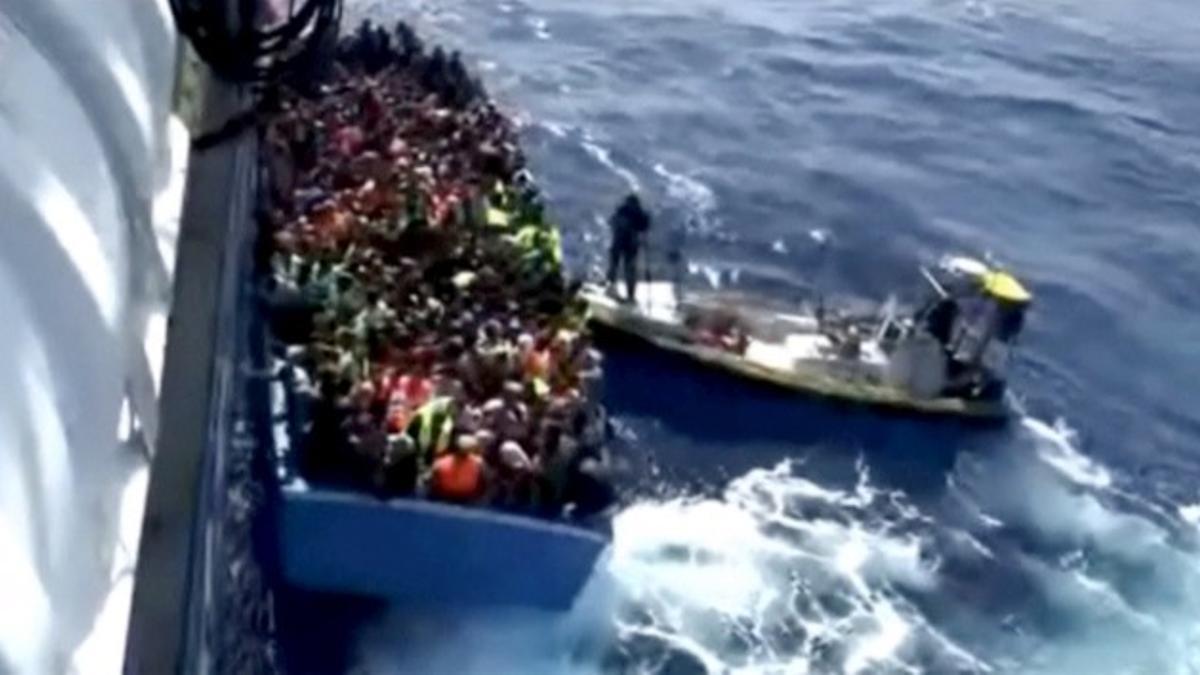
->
[254,24,616,609]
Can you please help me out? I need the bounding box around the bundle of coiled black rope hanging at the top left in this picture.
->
[170,0,342,83]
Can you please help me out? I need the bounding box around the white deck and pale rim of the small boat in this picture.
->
[583,281,1009,420]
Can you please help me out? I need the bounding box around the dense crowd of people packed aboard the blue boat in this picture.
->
[262,19,613,516]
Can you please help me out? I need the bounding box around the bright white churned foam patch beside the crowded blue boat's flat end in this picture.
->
[611,454,985,673]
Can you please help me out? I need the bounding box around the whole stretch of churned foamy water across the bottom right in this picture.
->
[362,419,1200,675]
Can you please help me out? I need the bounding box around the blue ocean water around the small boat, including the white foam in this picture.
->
[333,0,1200,675]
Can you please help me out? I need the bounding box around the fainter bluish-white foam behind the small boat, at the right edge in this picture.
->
[972,418,1200,675]
